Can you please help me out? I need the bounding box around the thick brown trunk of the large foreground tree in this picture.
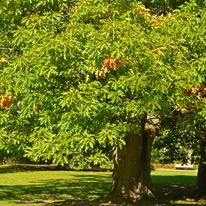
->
[110,116,159,205]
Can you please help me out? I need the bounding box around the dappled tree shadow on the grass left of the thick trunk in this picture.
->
[0,174,111,206]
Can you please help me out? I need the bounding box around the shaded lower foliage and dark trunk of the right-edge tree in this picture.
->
[155,85,206,196]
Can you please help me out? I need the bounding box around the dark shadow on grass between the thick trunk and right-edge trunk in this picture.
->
[148,174,206,206]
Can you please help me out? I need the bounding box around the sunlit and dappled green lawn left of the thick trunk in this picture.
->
[0,170,111,206]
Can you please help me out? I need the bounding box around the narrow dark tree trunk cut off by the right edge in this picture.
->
[197,138,206,197]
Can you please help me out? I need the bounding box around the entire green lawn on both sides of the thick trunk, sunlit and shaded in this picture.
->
[0,168,206,206]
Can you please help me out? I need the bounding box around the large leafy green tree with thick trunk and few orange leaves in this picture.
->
[0,0,205,203]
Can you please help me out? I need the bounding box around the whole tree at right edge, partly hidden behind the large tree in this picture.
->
[152,1,206,196]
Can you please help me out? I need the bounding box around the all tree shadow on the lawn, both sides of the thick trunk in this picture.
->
[0,172,206,206]
